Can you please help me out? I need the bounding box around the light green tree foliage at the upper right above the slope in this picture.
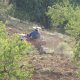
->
[47,0,80,37]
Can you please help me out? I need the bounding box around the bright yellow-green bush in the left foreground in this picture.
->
[0,22,33,80]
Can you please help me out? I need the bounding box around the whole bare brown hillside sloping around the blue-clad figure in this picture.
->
[7,20,79,80]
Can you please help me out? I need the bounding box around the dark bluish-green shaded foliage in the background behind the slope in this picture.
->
[8,0,56,26]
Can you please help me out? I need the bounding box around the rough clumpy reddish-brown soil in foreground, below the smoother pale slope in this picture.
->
[29,54,79,80]
